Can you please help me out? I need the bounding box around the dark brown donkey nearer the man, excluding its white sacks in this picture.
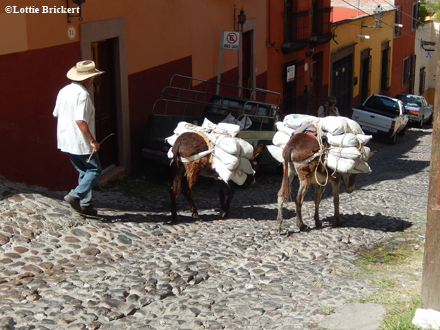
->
[170,132,264,220]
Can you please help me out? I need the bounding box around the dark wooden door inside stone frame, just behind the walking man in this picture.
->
[92,39,118,169]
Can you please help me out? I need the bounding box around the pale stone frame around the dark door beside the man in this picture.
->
[79,17,131,174]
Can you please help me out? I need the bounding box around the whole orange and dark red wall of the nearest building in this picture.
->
[0,0,267,190]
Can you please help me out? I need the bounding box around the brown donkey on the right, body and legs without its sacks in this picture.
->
[276,133,356,233]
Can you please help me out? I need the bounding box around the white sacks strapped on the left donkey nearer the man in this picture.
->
[165,118,255,185]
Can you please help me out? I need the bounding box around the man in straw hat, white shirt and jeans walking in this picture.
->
[53,61,104,215]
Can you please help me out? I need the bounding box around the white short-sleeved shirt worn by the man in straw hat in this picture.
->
[53,82,96,155]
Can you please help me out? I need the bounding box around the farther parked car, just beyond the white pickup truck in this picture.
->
[395,94,434,128]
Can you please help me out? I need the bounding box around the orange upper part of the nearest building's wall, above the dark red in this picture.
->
[0,0,267,79]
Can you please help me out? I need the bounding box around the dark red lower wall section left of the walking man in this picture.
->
[0,43,80,190]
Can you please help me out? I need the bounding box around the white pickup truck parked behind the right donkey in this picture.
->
[351,94,409,143]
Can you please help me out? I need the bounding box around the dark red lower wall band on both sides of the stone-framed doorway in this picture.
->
[0,47,254,190]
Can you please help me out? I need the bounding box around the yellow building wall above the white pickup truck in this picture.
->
[330,11,394,98]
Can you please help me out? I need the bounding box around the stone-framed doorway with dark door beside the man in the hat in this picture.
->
[79,17,131,178]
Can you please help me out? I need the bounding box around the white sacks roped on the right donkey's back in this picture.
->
[267,114,372,173]
